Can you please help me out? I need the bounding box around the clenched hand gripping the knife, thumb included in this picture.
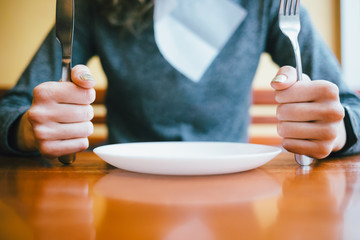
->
[17,65,95,158]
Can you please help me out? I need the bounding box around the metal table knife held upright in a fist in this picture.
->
[55,0,76,164]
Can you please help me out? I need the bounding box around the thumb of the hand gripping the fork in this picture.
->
[271,66,297,90]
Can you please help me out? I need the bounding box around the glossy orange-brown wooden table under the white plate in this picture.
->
[0,152,360,240]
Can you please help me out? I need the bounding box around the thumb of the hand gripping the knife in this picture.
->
[71,65,96,88]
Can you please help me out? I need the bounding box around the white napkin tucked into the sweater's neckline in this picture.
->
[154,0,247,82]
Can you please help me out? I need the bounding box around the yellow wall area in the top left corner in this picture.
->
[0,0,55,86]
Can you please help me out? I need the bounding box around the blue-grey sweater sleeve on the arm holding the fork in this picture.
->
[266,0,360,155]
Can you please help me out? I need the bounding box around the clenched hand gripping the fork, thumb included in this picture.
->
[271,66,346,159]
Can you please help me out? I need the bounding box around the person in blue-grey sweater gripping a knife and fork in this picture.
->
[0,0,360,158]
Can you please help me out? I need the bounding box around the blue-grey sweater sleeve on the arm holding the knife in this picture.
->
[0,1,94,156]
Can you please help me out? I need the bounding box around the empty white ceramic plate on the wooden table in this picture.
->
[94,142,281,175]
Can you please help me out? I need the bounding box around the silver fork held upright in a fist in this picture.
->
[279,0,313,166]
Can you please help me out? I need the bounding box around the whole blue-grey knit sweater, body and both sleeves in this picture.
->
[0,0,360,154]
